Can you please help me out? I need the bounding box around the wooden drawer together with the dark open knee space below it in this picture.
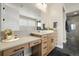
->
[29,39,41,56]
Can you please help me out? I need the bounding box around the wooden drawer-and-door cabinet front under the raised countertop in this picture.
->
[41,33,57,56]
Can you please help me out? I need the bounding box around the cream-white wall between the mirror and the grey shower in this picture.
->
[42,3,66,48]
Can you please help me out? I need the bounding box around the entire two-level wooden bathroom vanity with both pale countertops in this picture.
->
[0,31,57,56]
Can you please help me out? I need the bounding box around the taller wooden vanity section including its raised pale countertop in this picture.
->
[31,31,57,56]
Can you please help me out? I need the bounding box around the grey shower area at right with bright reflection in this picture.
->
[63,14,79,56]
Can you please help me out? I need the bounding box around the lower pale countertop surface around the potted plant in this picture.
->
[0,36,41,51]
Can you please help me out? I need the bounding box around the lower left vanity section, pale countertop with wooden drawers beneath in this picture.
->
[0,36,41,56]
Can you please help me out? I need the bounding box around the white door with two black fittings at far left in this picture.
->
[1,4,19,31]
